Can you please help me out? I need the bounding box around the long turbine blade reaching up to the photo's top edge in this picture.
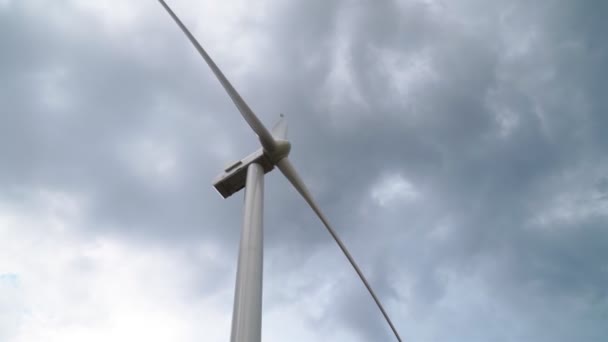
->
[158,0,276,151]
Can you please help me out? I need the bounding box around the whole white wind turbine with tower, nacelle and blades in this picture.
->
[158,0,401,342]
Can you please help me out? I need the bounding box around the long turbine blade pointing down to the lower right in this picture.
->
[277,157,401,342]
